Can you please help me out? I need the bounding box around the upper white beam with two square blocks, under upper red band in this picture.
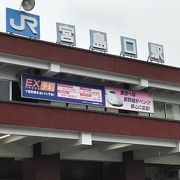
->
[0,53,180,92]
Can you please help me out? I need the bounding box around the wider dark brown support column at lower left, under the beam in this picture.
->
[23,145,60,180]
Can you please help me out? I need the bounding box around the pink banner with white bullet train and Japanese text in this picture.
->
[105,87,154,113]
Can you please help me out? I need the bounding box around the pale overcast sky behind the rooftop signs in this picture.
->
[0,0,180,67]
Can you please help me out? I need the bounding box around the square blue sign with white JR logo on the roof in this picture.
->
[6,8,40,39]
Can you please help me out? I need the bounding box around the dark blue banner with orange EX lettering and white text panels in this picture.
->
[21,75,105,107]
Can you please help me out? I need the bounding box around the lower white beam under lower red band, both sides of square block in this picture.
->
[0,125,177,148]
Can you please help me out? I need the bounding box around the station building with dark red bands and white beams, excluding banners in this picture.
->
[0,33,180,180]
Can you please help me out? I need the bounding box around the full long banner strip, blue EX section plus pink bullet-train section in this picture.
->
[21,74,154,113]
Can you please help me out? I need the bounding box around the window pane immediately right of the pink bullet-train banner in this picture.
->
[151,101,165,118]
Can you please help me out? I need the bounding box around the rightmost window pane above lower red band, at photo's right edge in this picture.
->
[166,104,180,120]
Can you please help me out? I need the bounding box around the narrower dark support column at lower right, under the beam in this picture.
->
[122,151,145,180]
